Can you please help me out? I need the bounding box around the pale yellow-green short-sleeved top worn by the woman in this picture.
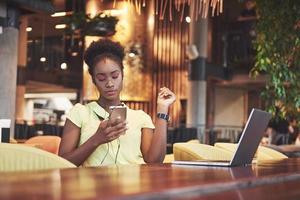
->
[67,102,155,166]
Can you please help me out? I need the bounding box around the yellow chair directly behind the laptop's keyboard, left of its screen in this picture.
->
[173,143,232,161]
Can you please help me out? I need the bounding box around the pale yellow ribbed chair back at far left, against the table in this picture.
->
[0,143,76,172]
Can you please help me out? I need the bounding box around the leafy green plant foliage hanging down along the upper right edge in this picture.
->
[251,0,300,120]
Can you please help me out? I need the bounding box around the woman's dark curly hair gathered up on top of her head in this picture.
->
[84,39,125,77]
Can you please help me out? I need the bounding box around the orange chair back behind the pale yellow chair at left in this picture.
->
[25,135,61,155]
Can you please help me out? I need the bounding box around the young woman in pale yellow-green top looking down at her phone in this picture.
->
[59,39,176,166]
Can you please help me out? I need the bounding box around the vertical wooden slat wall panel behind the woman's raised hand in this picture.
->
[150,2,189,127]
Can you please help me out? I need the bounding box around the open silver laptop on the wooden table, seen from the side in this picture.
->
[172,108,272,167]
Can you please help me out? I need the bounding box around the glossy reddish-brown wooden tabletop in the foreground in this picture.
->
[0,158,300,199]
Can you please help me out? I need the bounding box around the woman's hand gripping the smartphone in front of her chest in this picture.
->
[95,119,127,145]
